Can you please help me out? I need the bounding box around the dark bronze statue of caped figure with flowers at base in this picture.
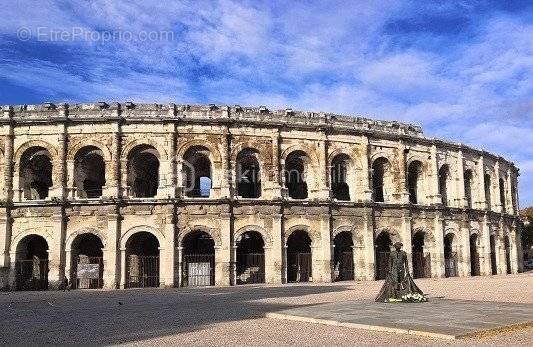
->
[376,242,426,302]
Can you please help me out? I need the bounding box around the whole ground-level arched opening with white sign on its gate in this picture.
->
[70,233,104,289]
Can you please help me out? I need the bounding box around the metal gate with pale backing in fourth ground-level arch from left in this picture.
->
[183,254,215,287]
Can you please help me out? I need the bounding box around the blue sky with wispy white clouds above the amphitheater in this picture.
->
[0,0,533,207]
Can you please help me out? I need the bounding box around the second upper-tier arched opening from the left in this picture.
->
[74,146,105,198]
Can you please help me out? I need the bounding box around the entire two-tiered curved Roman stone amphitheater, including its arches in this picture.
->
[0,102,522,290]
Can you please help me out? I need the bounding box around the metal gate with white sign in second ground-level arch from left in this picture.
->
[70,255,104,289]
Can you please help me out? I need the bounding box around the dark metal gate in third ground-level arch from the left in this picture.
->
[126,254,159,288]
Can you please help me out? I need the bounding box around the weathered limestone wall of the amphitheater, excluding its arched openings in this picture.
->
[0,103,522,288]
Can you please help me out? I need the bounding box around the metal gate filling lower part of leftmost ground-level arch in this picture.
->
[15,259,48,290]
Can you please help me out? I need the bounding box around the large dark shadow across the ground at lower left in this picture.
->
[0,285,348,345]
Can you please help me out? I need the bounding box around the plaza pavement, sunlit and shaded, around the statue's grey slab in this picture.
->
[0,273,533,346]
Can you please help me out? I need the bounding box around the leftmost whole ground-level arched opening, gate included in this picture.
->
[15,235,48,290]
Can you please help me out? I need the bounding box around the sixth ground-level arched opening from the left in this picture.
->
[287,230,312,282]
